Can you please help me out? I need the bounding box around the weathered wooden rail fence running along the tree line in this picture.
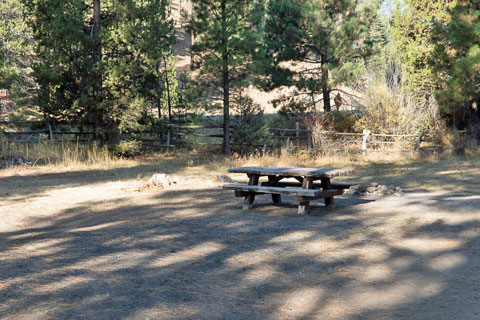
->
[0,121,438,153]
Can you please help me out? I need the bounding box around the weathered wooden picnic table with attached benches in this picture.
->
[223,167,355,214]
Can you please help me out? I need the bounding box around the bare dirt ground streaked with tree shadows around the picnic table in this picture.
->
[0,158,480,320]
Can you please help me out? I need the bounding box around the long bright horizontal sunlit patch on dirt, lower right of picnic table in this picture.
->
[392,238,462,254]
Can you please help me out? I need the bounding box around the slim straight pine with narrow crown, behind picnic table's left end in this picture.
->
[189,0,263,154]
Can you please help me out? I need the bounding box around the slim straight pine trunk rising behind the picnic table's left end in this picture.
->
[222,0,231,155]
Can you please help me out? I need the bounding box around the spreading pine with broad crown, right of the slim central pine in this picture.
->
[265,0,379,112]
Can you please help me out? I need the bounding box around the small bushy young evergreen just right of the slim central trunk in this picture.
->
[231,92,272,153]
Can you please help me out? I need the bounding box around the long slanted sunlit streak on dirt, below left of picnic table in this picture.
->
[149,242,225,267]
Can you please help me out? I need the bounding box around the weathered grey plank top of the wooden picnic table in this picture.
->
[228,167,355,178]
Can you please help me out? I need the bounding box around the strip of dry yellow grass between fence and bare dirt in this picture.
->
[0,143,480,193]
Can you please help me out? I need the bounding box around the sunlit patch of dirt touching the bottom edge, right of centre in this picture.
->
[271,287,324,319]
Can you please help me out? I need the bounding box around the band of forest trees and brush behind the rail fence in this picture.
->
[0,0,480,154]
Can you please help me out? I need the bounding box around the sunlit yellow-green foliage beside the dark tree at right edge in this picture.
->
[392,0,456,95]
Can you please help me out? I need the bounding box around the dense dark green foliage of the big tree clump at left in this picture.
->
[23,0,173,142]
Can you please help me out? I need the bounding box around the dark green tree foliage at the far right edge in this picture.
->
[430,0,480,131]
